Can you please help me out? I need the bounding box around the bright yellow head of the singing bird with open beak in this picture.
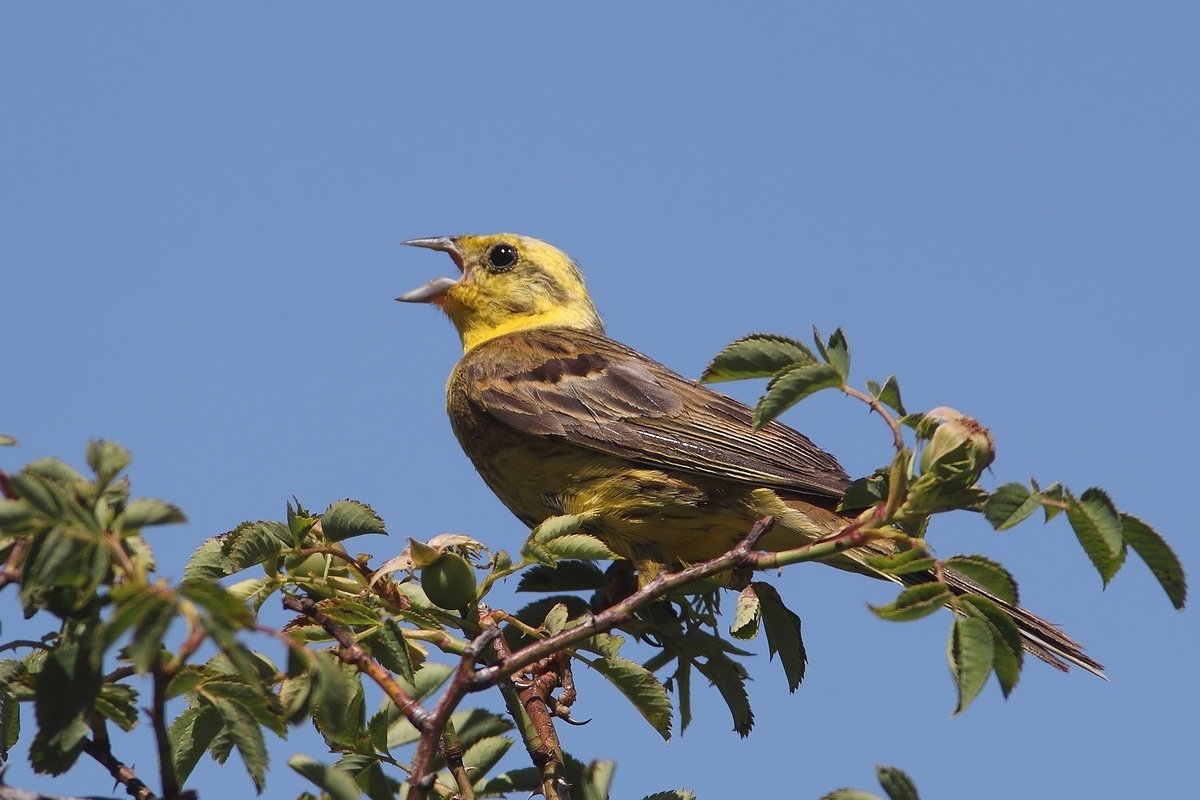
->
[396,234,604,350]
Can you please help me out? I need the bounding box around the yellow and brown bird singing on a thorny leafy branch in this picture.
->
[397,234,1103,675]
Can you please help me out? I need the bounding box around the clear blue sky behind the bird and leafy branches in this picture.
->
[0,1,1200,800]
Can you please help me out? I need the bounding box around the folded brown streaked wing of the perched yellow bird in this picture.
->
[452,329,850,498]
